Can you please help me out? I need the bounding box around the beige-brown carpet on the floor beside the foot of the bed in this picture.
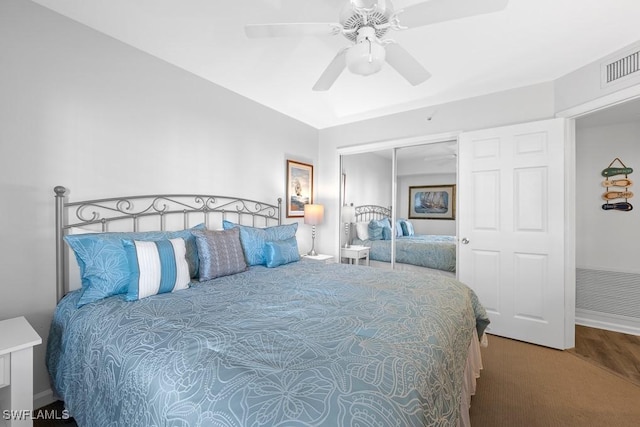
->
[471,336,640,427]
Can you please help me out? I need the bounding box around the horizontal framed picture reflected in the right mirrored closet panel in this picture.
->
[408,185,456,219]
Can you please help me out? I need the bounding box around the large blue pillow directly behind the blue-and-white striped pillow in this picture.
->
[64,224,205,307]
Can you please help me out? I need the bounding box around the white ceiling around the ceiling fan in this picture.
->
[33,0,640,129]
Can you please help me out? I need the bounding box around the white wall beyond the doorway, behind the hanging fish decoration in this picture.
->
[576,119,640,272]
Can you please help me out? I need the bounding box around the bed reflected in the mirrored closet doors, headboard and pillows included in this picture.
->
[352,205,456,276]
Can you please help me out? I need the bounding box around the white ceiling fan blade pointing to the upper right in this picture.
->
[398,0,509,28]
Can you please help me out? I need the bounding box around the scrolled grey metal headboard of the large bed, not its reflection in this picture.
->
[53,186,282,301]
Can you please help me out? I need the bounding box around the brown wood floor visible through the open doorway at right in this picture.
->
[568,325,640,387]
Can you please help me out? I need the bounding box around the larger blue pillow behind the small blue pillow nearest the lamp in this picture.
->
[222,220,298,265]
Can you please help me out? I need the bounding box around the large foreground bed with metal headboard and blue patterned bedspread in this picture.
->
[46,187,489,427]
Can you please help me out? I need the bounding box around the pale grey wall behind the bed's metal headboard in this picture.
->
[0,0,322,402]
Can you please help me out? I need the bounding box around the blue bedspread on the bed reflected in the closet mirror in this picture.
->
[353,234,456,271]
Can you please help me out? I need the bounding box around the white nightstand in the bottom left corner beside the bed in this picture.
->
[0,317,42,427]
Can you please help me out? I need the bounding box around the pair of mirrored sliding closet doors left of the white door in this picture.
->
[340,141,457,275]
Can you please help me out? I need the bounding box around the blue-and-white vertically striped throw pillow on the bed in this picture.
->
[122,238,190,301]
